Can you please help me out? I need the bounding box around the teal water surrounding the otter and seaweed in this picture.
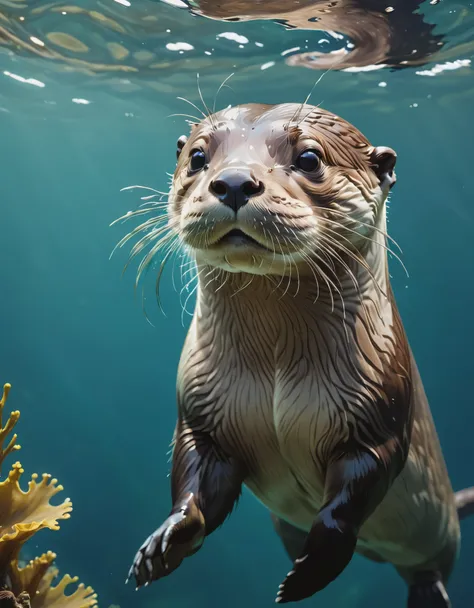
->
[0,0,474,608]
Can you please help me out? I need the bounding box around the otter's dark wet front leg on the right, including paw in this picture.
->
[276,451,389,603]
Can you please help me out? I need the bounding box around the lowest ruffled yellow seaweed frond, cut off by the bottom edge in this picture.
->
[31,569,97,608]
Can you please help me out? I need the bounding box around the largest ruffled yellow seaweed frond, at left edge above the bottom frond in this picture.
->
[0,462,72,572]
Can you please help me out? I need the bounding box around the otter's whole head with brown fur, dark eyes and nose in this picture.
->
[169,104,396,275]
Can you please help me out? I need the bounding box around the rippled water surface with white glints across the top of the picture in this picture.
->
[0,0,474,117]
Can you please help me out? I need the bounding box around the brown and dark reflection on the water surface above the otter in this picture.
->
[189,0,444,70]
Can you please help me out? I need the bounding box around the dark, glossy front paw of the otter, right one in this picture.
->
[275,514,357,604]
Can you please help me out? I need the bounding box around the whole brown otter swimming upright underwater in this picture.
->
[123,104,474,608]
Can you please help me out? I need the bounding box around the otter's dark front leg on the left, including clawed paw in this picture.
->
[127,423,244,588]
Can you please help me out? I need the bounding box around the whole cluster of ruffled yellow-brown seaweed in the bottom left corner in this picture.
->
[0,384,97,608]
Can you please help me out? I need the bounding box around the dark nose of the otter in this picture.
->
[209,169,264,213]
